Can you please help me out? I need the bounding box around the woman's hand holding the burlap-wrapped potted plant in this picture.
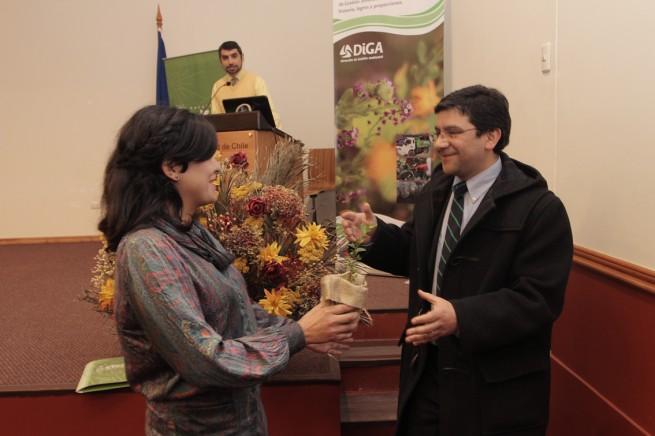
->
[298,302,359,348]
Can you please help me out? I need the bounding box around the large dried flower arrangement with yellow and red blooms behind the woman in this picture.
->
[83,141,370,320]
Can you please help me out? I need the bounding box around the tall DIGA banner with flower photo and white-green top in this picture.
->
[333,0,445,219]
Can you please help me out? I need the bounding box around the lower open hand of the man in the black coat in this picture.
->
[405,290,457,345]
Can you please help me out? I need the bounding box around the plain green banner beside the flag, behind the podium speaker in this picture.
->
[164,50,225,113]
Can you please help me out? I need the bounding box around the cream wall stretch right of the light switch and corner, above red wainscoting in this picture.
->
[557,0,655,269]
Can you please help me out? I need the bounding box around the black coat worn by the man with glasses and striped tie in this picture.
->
[363,153,573,436]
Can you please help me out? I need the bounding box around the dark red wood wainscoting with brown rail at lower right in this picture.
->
[549,247,655,436]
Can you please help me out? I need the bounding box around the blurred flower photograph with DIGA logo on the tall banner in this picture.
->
[334,22,443,220]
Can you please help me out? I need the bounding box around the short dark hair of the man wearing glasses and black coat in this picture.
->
[434,85,512,153]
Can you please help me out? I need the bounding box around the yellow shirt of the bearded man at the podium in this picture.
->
[211,69,280,128]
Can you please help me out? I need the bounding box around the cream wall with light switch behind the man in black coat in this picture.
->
[447,0,655,268]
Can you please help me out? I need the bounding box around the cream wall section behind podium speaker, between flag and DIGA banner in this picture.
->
[158,0,334,148]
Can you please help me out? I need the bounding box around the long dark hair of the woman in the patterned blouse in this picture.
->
[98,106,216,251]
